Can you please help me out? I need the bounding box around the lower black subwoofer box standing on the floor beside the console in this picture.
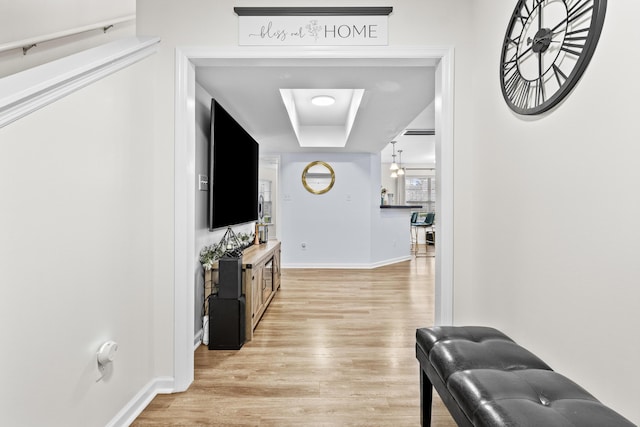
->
[209,296,245,350]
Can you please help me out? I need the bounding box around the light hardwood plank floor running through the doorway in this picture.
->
[133,247,456,427]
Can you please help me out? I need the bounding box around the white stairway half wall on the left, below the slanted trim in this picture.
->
[0,58,156,427]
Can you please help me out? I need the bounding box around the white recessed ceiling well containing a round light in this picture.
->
[280,89,364,148]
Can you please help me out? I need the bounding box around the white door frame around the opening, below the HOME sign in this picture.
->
[174,46,454,391]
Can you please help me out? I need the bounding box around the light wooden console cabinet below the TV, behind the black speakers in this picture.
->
[212,240,281,341]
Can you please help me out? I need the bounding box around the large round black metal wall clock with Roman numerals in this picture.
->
[500,0,607,115]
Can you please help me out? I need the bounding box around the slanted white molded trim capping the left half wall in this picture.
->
[0,37,160,128]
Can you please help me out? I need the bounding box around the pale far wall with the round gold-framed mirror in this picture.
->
[279,153,409,268]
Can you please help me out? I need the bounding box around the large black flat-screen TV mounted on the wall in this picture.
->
[209,99,258,231]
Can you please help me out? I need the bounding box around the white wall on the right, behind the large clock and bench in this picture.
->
[455,0,640,423]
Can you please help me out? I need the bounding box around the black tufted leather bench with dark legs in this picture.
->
[416,326,634,427]
